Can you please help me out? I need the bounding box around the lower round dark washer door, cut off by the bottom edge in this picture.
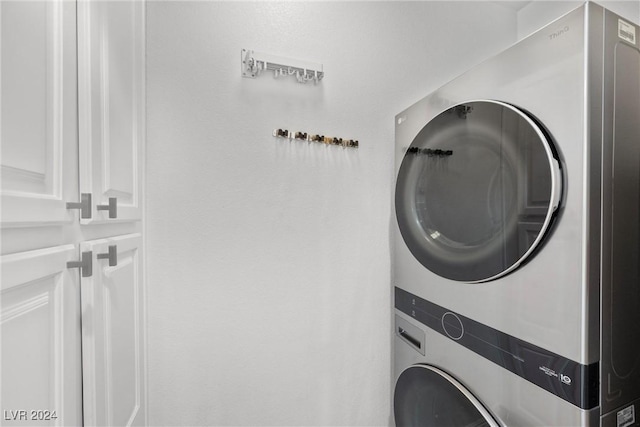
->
[393,365,498,427]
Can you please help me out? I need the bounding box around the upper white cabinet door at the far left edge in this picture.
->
[0,1,78,227]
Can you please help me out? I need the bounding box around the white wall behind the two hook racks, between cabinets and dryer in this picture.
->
[147,2,516,425]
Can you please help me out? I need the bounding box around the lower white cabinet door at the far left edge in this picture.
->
[0,245,82,426]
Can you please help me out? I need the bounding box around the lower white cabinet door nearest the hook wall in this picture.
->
[81,234,146,426]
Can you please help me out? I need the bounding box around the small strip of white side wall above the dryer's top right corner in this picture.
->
[518,0,640,39]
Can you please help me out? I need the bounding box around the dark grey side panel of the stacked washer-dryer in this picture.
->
[600,6,640,427]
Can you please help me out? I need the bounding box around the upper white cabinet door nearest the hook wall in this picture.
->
[78,0,145,224]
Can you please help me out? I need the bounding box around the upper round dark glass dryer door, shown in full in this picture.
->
[395,101,562,282]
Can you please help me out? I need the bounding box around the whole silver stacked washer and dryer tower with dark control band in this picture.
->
[393,3,640,427]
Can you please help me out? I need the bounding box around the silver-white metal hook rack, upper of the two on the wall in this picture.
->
[240,49,324,84]
